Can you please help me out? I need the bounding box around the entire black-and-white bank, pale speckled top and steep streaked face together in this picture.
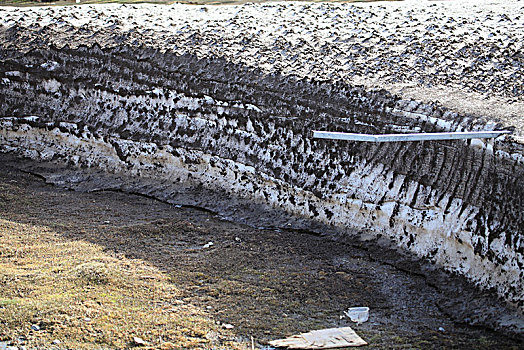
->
[0,1,524,344]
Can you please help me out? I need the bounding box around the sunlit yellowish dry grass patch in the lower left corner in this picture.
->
[0,219,247,349]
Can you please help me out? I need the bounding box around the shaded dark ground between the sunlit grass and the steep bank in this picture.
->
[0,155,522,349]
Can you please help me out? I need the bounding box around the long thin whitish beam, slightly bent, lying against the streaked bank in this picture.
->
[313,130,510,142]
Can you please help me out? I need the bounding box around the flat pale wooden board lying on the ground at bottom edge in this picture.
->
[269,327,367,350]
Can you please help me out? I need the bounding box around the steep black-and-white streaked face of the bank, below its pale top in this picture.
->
[0,0,524,340]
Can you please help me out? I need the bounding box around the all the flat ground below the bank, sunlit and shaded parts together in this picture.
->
[0,155,522,349]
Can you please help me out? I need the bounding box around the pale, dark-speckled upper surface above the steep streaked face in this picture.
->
[0,0,524,133]
